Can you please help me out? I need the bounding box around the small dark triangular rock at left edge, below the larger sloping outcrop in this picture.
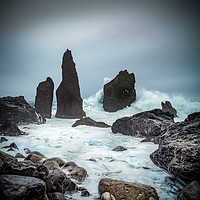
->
[0,120,26,136]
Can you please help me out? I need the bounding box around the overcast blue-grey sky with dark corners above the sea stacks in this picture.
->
[0,0,200,101]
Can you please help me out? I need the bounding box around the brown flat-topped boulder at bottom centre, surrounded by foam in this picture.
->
[98,178,158,200]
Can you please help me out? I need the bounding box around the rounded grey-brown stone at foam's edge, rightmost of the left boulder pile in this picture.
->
[62,162,87,181]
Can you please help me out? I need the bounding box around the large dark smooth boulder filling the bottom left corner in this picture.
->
[0,175,48,200]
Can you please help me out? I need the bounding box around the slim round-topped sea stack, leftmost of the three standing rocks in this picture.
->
[35,77,54,118]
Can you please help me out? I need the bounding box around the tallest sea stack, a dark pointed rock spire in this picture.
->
[56,49,85,119]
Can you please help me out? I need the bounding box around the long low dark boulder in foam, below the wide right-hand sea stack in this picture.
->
[112,109,174,137]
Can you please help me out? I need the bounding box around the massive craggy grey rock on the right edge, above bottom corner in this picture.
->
[150,112,200,182]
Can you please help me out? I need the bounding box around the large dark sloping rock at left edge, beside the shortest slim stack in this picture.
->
[0,96,45,124]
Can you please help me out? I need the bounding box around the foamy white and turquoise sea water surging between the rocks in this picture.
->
[0,90,200,200]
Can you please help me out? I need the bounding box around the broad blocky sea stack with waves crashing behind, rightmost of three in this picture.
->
[103,70,136,112]
